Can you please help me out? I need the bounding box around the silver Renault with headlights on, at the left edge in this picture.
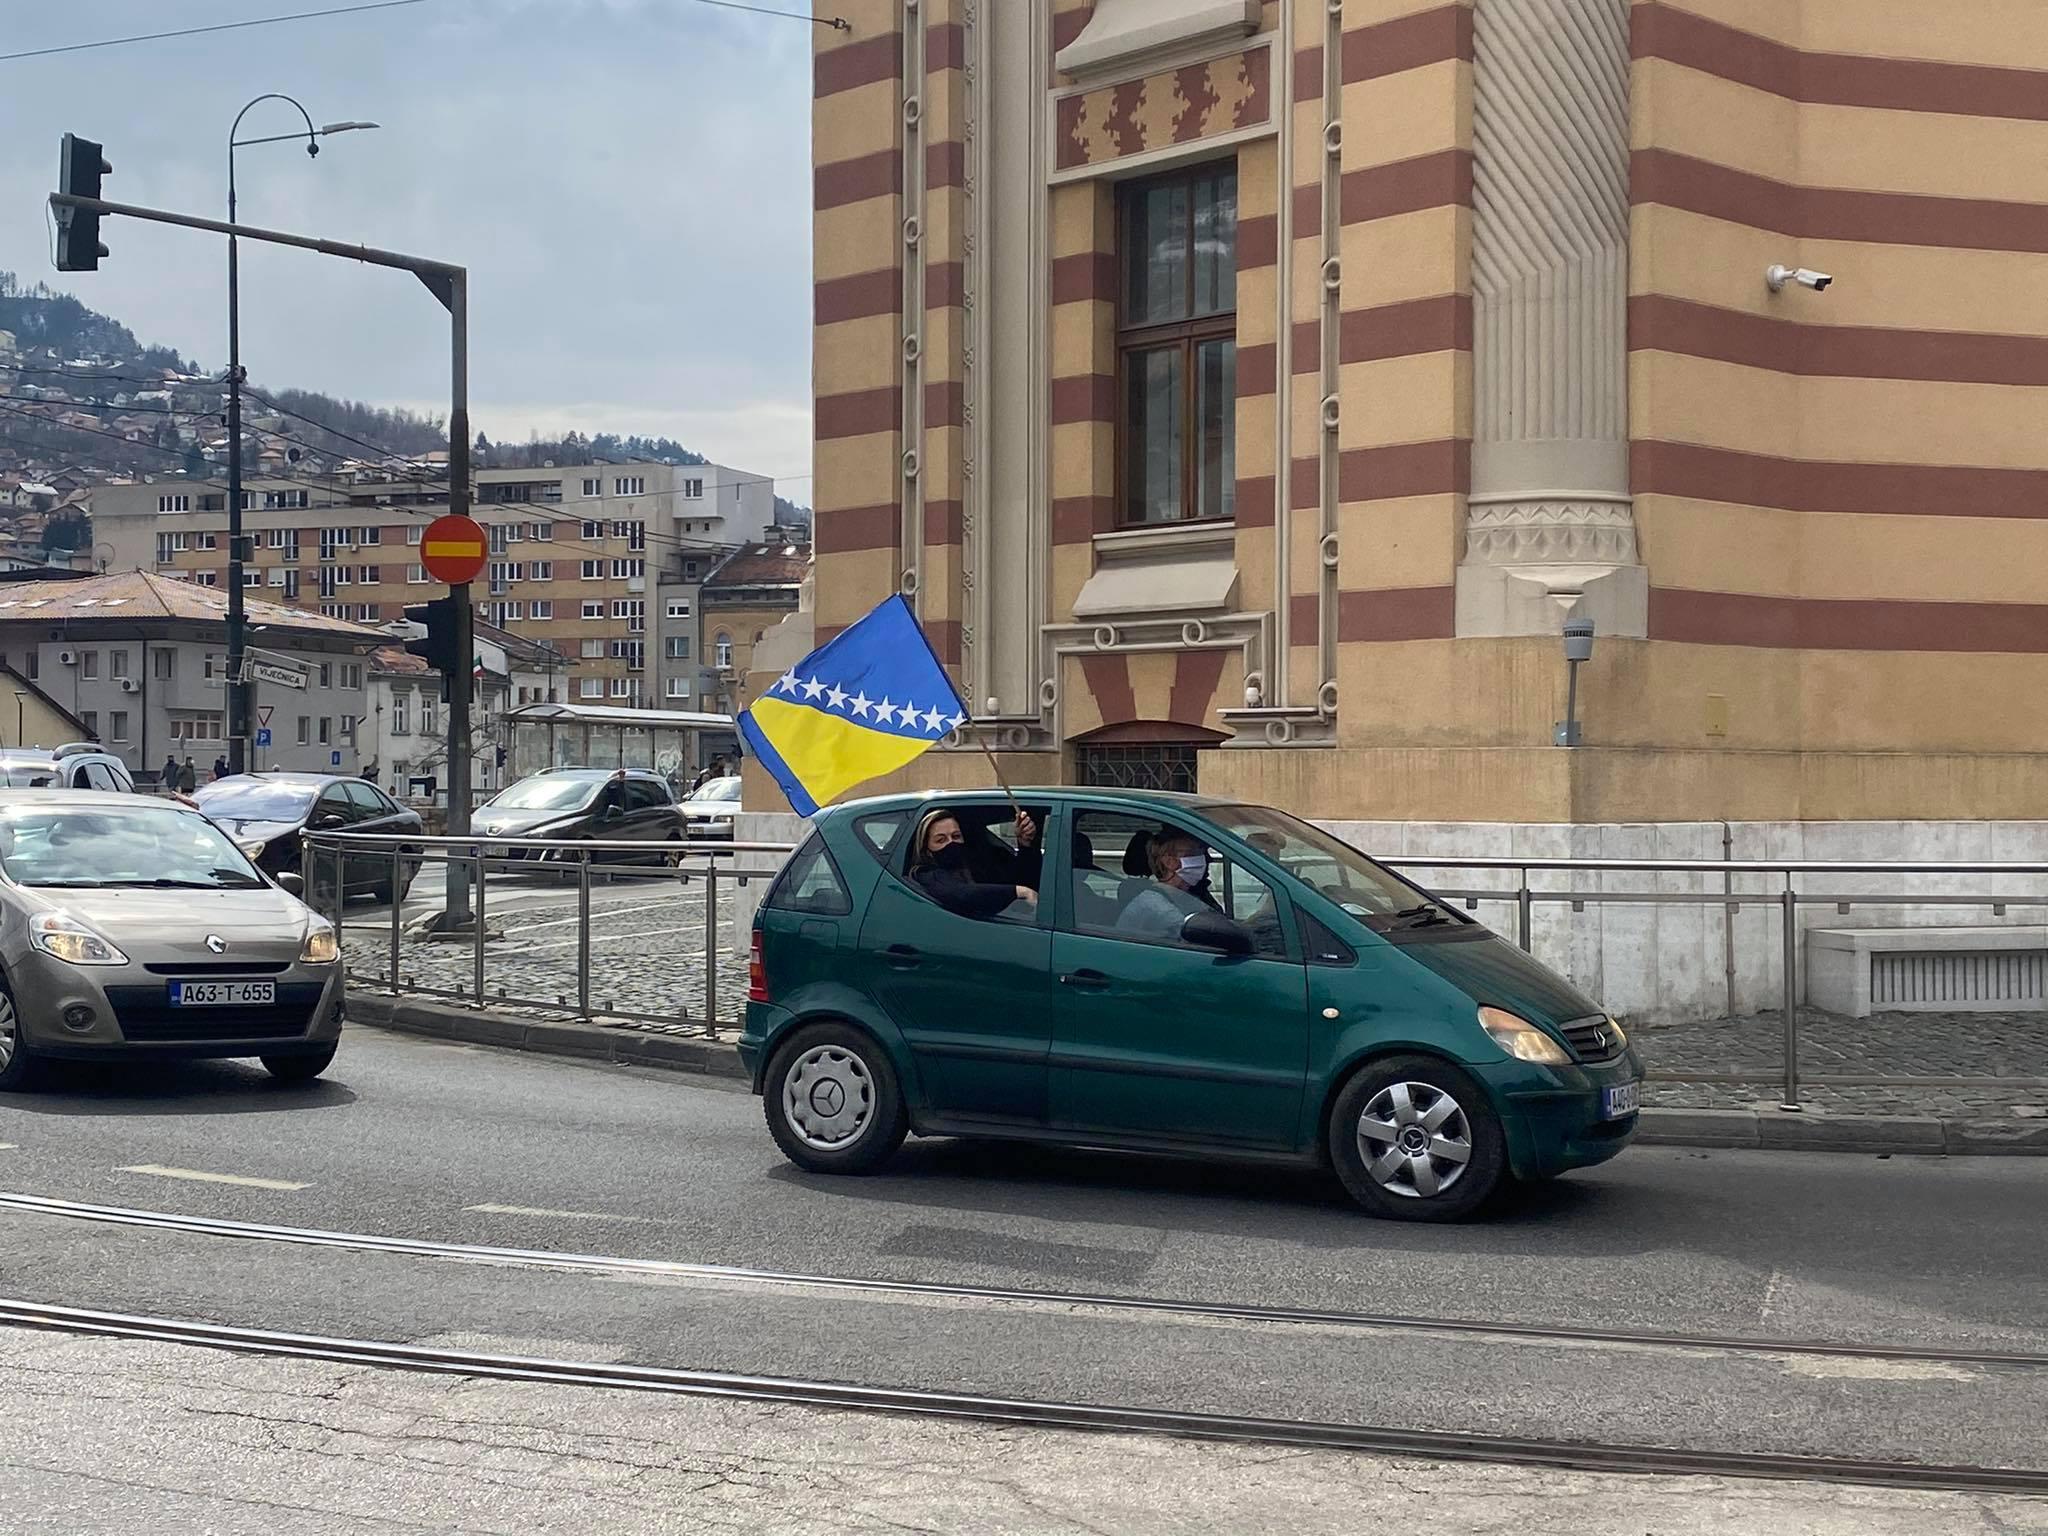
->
[0,788,342,1090]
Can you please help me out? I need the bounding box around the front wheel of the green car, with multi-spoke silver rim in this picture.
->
[1329,1057,1507,1221]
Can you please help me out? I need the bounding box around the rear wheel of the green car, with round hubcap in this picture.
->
[762,1024,909,1174]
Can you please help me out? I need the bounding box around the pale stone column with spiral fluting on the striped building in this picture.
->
[1458,0,1649,639]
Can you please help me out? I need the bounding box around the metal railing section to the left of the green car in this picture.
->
[299,831,791,1036]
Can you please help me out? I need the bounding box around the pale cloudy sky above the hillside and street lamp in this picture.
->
[0,0,811,502]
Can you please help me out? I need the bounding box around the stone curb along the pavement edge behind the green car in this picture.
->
[348,993,2048,1157]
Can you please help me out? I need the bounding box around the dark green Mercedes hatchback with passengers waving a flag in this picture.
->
[739,788,1642,1221]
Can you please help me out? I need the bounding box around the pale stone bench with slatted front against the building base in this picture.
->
[1806,928,2048,1018]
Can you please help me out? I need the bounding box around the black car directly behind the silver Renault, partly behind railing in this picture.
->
[193,772,426,905]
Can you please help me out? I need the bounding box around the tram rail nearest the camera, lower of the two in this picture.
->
[0,1300,2048,1497]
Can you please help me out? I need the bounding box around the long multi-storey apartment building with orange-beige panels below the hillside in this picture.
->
[94,463,774,707]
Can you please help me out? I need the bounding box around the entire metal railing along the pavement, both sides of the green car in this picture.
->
[301,834,2048,1108]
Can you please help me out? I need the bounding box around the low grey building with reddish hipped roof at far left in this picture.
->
[0,571,383,772]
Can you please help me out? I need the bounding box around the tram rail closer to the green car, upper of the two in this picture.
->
[0,1192,2048,1370]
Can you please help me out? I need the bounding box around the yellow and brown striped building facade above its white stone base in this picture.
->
[813,0,2048,823]
